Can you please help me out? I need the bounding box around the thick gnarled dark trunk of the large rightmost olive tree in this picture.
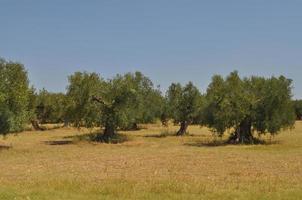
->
[230,119,254,144]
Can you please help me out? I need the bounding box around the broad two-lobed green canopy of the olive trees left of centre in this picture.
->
[67,72,162,137]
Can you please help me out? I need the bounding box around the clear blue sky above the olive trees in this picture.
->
[0,0,302,98]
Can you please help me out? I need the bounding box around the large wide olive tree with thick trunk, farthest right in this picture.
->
[202,72,294,143]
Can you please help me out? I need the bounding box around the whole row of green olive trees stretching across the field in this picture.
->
[0,59,302,143]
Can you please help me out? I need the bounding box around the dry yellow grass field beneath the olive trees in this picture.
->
[0,122,302,200]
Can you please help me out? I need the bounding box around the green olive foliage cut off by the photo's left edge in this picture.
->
[0,59,32,134]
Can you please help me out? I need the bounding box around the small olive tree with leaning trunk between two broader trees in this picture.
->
[166,82,202,136]
